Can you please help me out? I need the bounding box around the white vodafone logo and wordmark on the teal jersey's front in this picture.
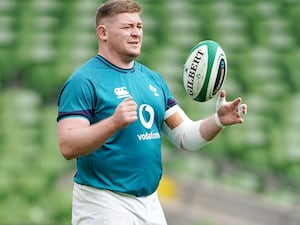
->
[137,104,160,141]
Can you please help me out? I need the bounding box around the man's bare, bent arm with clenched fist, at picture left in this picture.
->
[57,98,137,159]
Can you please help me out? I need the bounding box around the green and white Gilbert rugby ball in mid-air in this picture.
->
[183,40,227,102]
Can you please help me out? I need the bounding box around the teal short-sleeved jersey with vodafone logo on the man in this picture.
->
[57,55,176,196]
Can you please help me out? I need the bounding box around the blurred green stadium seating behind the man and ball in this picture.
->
[0,0,300,225]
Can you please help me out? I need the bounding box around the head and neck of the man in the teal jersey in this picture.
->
[96,0,143,68]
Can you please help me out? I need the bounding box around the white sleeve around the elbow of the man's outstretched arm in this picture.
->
[162,105,208,151]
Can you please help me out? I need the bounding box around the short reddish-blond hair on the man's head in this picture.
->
[96,0,142,26]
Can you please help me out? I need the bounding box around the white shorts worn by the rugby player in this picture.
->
[72,183,167,225]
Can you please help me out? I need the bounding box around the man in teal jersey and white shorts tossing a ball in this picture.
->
[57,0,246,225]
